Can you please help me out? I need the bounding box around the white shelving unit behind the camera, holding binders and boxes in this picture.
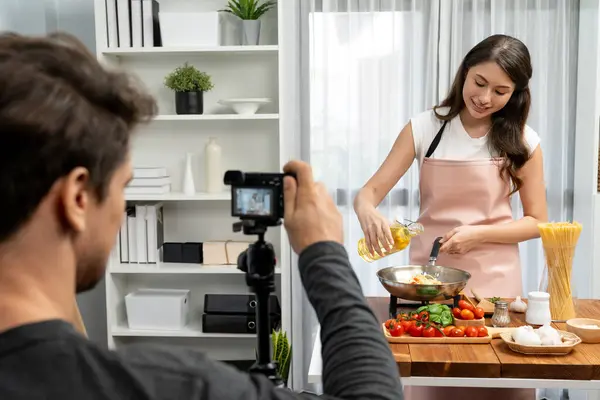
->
[94,0,291,360]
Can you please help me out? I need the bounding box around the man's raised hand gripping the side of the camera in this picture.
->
[283,161,344,254]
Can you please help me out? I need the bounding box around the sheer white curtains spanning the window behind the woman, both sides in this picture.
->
[308,0,579,296]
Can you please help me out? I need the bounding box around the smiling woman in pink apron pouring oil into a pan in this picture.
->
[354,35,547,400]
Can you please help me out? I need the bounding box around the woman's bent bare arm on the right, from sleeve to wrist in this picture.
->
[483,145,548,243]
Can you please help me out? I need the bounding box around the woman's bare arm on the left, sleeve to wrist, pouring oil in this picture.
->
[354,122,415,211]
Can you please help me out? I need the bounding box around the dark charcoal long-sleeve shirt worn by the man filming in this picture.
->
[0,242,403,400]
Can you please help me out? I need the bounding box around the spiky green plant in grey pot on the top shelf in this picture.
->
[221,0,277,45]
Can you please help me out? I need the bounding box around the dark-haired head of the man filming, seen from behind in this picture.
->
[0,34,156,292]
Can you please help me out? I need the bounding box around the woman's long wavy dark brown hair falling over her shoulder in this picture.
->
[434,35,532,194]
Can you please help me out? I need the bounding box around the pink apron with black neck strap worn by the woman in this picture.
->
[405,123,535,400]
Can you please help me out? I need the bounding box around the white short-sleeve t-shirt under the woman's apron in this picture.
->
[410,107,540,166]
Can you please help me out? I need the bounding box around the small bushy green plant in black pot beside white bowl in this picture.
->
[165,62,214,114]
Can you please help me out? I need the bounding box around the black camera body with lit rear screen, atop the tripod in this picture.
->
[223,170,294,226]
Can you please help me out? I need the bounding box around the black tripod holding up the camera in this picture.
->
[233,220,284,387]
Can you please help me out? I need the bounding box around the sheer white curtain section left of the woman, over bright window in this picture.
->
[309,0,439,295]
